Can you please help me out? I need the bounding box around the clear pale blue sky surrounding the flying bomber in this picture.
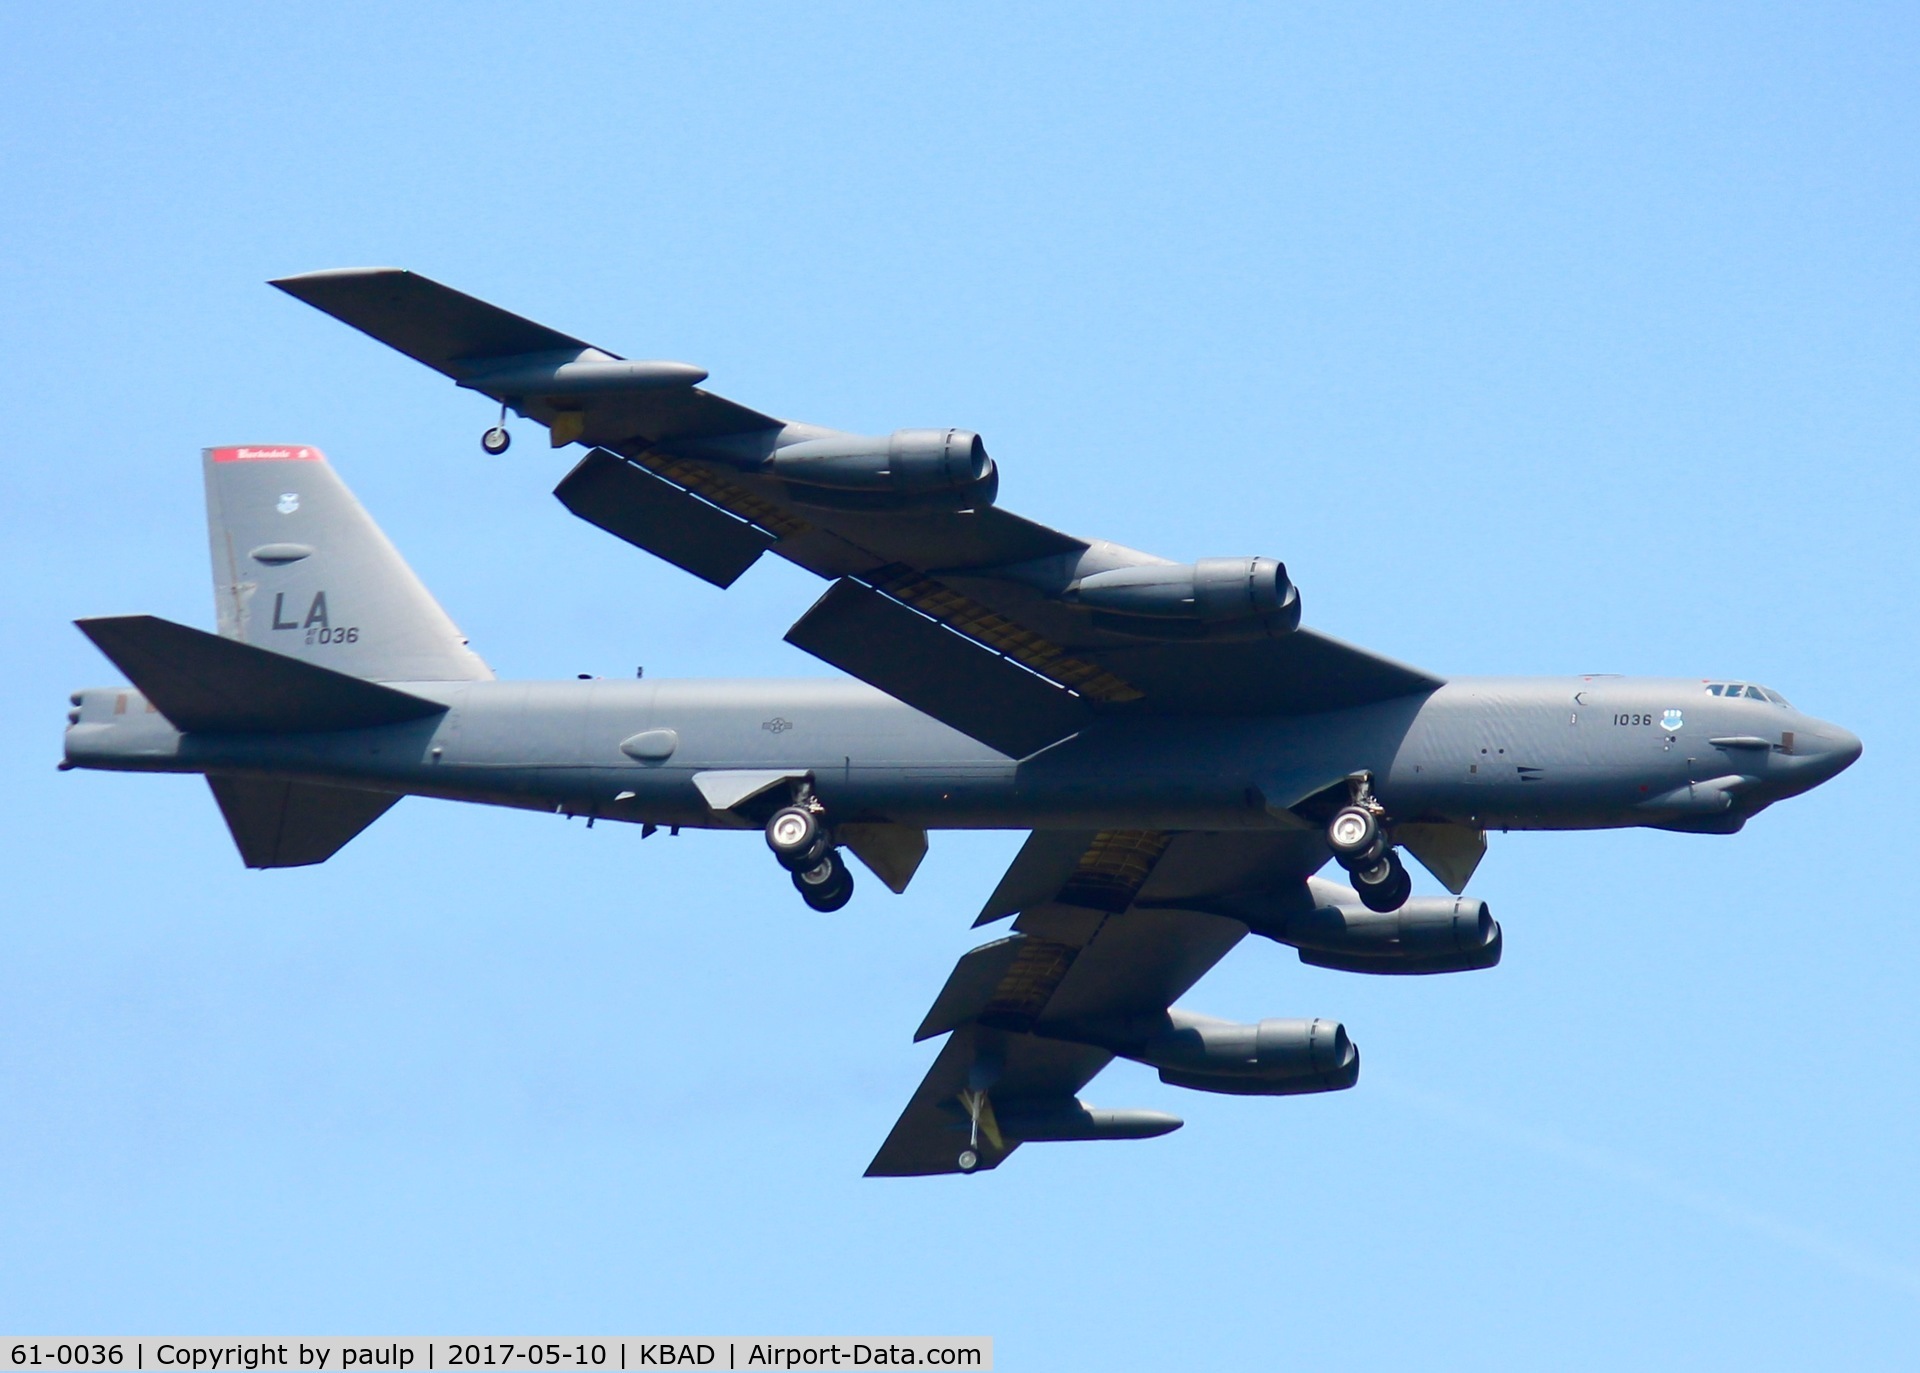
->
[0,4,1920,1369]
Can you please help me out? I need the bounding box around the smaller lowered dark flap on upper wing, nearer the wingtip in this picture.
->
[553,447,776,586]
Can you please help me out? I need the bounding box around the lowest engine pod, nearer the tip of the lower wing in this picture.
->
[1127,1010,1359,1096]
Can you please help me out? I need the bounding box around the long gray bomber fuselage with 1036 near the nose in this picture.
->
[65,676,1860,831]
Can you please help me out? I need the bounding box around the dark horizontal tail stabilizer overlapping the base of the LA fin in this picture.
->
[75,614,447,737]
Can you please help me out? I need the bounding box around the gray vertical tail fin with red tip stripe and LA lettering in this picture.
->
[204,444,493,682]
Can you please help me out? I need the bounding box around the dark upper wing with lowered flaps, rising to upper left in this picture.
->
[273,269,1440,757]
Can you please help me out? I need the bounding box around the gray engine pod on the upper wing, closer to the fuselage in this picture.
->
[1062,557,1300,639]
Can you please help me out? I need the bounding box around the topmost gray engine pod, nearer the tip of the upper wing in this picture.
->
[766,428,1000,509]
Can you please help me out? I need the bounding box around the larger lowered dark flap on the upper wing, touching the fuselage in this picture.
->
[787,578,1092,759]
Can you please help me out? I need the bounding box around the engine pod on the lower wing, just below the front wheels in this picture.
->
[1261,897,1501,976]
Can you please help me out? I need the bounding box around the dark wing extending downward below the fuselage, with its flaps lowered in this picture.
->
[866,830,1323,1177]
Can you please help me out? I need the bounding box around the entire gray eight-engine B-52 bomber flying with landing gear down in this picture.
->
[63,269,1860,1175]
